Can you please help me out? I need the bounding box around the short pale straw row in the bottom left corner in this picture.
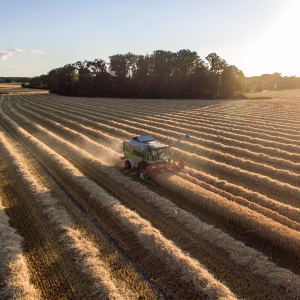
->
[0,192,40,300]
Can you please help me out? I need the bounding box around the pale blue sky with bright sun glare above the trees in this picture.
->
[0,0,300,77]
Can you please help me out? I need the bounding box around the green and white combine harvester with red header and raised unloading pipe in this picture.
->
[121,134,190,185]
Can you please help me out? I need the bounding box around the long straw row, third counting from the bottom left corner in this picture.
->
[0,99,236,299]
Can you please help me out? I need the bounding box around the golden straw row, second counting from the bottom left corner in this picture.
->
[0,135,125,299]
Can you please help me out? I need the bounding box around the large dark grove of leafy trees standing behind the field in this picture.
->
[24,49,246,99]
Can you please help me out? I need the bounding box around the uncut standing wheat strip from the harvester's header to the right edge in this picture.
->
[157,173,300,255]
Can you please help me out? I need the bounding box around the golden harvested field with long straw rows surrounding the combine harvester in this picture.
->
[0,92,300,300]
